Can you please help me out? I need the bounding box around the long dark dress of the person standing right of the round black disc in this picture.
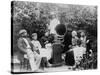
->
[63,32,75,66]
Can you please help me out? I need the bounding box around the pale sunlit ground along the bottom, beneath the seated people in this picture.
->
[13,65,75,72]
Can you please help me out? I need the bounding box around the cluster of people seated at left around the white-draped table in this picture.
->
[17,29,52,71]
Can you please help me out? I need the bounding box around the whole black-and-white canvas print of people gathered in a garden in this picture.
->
[11,1,98,73]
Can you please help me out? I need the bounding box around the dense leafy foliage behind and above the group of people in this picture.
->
[11,1,97,69]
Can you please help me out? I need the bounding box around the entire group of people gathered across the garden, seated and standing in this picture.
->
[18,29,90,72]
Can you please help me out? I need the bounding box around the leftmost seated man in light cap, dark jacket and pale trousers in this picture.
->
[18,29,37,71]
